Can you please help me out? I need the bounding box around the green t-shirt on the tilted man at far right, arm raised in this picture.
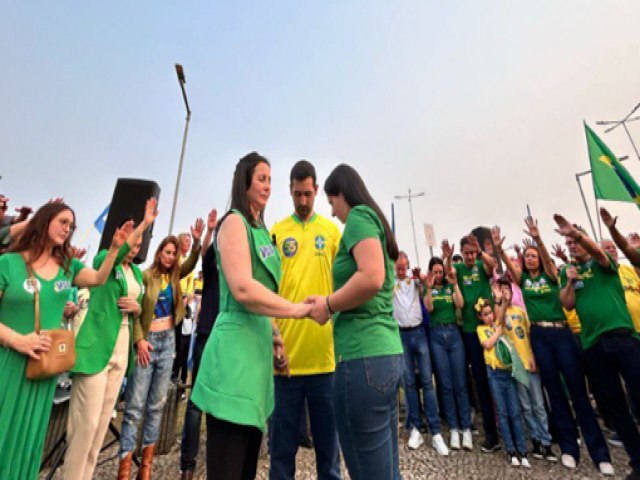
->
[560,254,634,350]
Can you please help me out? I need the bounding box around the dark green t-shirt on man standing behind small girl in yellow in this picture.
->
[454,260,493,333]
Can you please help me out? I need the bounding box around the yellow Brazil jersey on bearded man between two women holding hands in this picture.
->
[271,214,340,375]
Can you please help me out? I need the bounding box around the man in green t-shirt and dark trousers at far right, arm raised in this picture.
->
[554,214,640,478]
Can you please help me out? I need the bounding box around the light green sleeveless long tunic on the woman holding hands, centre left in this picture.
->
[191,211,280,431]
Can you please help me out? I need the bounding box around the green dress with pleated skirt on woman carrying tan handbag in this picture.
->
[0,253,84,480]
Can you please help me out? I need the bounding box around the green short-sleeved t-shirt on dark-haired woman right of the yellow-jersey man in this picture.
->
[333,205,402,362]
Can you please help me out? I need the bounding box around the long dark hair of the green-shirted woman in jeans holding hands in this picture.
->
[324,163,398,262]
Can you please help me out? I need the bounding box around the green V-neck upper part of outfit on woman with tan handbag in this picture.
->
[0,253,84,335]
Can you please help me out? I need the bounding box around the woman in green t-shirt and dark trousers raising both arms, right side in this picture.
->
[492,217,611,469]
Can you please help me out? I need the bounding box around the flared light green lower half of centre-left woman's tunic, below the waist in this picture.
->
[191,312,274,431]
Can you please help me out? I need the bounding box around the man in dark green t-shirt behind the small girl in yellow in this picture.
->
[442,235,500,453]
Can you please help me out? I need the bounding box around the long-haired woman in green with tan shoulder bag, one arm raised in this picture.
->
[0,202,132,480]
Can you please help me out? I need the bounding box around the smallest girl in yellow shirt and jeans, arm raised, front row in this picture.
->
[475,295,531,468]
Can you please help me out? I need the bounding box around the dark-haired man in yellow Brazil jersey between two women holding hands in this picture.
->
[269,160,341,480]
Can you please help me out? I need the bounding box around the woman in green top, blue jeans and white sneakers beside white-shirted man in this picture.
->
[424,257,473,450]
